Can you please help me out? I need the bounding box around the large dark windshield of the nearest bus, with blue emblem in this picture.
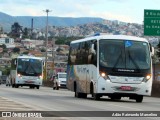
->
[99,40,150,71]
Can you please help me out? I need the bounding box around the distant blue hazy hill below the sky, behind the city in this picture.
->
[0,12,104,32]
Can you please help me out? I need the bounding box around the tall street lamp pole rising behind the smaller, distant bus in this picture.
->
[44,9,51,80]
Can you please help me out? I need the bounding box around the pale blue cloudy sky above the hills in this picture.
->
[0,0,160,24]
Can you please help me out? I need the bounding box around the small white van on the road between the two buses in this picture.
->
[53,72,67,90]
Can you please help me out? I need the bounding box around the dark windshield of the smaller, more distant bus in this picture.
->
[17,58,42,76]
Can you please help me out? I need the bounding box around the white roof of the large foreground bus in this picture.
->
[71,35,148,44]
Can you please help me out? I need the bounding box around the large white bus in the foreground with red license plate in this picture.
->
[67,35,154,102]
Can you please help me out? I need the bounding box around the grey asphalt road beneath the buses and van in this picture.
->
[0,85,160,120]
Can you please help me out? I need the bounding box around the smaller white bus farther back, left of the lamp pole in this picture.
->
[10,55,43,89]
